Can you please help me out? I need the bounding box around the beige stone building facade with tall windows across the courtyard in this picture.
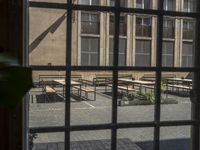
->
[29,0,195,79]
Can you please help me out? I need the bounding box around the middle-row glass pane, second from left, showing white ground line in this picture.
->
[71,71,112,125]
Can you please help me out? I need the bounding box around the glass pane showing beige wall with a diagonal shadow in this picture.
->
[29,8,66,66]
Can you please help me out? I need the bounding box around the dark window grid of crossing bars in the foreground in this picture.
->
[25,0,200,150]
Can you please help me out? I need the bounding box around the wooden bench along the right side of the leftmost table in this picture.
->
[73,86,96,100]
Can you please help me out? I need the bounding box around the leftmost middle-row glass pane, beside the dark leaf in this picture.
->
[29,71,65,127]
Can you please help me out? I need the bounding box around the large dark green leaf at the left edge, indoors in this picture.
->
[0,54,33,108]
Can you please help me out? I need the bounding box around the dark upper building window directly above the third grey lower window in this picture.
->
[136,17,151,37]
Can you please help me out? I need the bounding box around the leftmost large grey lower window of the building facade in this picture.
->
[81,37,99,66]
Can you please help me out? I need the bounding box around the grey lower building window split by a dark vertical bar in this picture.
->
[109,38,126,66]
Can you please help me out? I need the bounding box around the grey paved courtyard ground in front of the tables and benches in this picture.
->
[29,88,191,150]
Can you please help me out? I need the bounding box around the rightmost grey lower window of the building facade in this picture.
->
[182,42,193,67]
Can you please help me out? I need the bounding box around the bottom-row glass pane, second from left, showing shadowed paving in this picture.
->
[70,130,111,150]
